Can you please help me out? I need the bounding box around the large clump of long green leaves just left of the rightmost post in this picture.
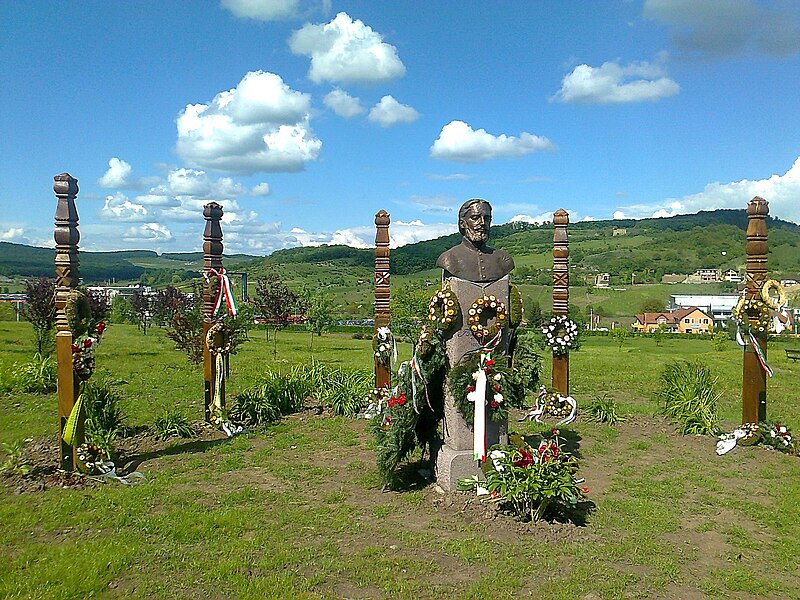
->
[656,362,719,435]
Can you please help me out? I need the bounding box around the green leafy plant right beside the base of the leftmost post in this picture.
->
[81,380,127,456]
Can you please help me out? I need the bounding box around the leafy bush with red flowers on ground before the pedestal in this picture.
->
[458,429,589,521]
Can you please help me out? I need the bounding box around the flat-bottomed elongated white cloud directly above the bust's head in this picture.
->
[430,121,555,162]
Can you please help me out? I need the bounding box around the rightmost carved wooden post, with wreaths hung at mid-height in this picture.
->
[742,196,769,423]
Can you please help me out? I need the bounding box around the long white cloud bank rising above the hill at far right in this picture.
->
[614,157,800,223]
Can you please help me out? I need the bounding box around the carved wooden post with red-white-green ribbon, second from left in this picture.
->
[203,202,225,421]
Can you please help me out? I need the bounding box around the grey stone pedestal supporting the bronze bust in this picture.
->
[436,276,510,491]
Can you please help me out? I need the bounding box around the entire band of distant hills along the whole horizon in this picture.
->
[0,210,800,285]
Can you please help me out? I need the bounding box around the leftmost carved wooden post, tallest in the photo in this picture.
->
[53,173,83,471]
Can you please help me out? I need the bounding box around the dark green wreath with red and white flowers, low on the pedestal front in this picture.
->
[448,353,525,425]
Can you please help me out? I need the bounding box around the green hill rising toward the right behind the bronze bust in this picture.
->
[256,210,800,279]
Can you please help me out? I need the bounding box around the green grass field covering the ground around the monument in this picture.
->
[0,322,800,599]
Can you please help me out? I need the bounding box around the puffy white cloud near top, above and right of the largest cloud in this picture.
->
[289,12,406,83]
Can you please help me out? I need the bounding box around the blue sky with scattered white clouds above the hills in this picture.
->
[0,0,800,254]
